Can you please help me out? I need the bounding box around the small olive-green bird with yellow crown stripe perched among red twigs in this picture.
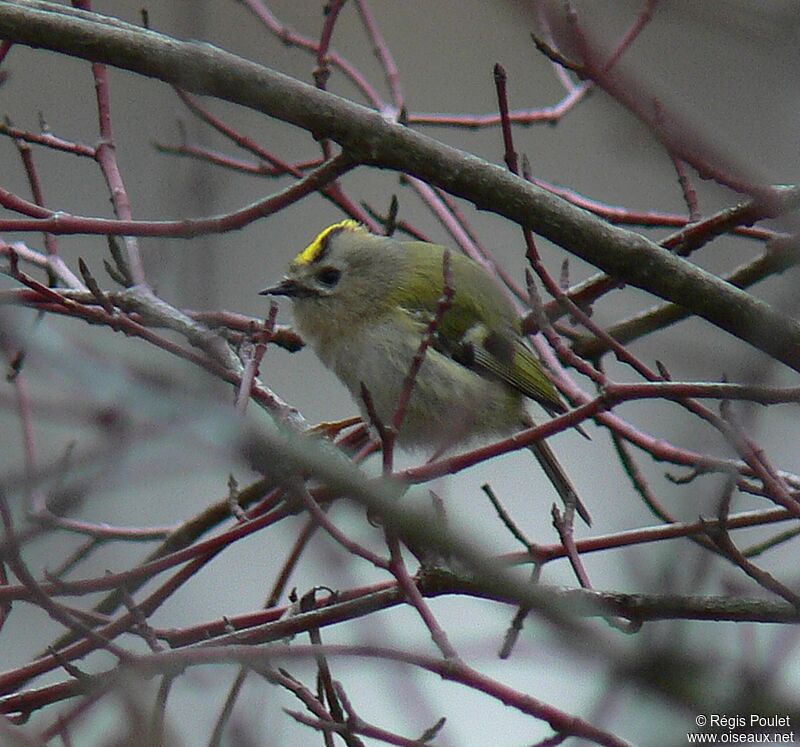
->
[261,220,591,524]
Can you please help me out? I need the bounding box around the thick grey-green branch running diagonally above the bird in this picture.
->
[0,0,800,371]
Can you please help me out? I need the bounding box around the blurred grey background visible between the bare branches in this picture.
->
[0,0,800,745]
